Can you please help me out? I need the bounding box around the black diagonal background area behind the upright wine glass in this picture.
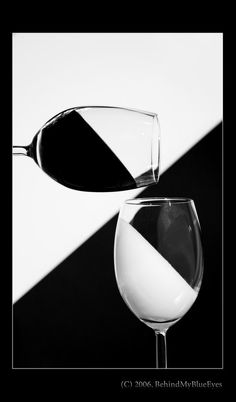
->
[13,124,222,372]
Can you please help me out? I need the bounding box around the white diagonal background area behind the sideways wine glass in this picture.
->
[13,33,222,301]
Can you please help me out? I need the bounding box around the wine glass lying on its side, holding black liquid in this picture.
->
[13,106,160,192]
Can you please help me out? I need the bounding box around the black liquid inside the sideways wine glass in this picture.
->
[34,110,136,191]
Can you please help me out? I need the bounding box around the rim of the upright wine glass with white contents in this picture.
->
[125,197,194,206]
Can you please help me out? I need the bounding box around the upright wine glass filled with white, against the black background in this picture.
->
[114,198,203,368]
